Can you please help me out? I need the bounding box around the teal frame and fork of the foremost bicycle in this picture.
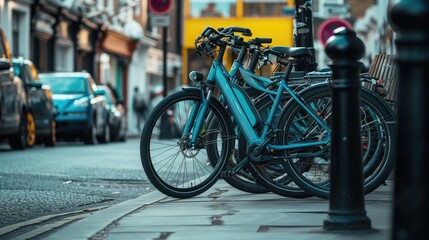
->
[182,41,331,167]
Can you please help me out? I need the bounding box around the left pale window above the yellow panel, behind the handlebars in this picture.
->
[189,0,236,18]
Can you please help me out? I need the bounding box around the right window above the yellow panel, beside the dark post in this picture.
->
[243,0,287,17]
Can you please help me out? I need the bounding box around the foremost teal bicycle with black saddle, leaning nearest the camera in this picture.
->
[140,27,390,198]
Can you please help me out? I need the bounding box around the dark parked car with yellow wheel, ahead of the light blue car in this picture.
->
[12,58,56,147]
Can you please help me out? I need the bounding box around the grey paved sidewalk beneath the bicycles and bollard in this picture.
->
[45,180,393,240]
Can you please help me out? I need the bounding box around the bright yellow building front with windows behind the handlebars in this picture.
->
[182,0,294,84]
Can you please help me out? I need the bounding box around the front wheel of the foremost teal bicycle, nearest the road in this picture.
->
[140,89,235,198]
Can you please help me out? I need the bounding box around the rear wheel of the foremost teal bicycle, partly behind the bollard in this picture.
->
[279,84,395,199]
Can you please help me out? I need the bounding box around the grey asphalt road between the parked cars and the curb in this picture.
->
[0,138,154,239]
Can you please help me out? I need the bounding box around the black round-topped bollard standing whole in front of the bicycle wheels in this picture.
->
[323,27,371,230]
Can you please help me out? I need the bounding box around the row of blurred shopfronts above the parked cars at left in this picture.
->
[0,0,181,135]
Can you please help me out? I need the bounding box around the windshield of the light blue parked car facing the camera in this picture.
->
[40,77,88,94]
